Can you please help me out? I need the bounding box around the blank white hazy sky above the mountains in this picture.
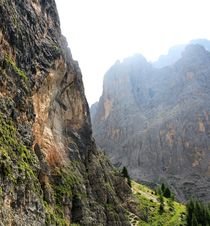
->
[56,0,210,105]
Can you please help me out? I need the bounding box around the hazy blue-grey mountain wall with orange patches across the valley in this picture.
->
[91,45,210,201]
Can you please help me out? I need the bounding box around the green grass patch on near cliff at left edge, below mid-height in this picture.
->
[0,114,35,183]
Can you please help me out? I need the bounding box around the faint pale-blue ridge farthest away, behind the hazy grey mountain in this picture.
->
[153,39,210,68]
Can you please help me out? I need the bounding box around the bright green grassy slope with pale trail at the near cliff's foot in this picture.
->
[129,181,186,226]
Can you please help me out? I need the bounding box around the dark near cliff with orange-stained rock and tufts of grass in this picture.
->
[0,0,134,226]
